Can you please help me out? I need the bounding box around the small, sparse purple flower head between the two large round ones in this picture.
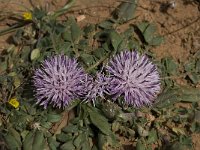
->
[81,73,108,104]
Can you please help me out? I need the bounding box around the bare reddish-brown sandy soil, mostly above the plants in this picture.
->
[0,0,200,150]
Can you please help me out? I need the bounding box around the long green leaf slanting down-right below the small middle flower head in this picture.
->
[88,107,111,135]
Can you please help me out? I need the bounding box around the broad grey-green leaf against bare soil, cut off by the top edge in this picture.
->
[115,0,137,23]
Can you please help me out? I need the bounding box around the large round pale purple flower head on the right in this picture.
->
[106,51,160,107]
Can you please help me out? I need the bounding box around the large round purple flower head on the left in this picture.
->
[33,55,85,108]
